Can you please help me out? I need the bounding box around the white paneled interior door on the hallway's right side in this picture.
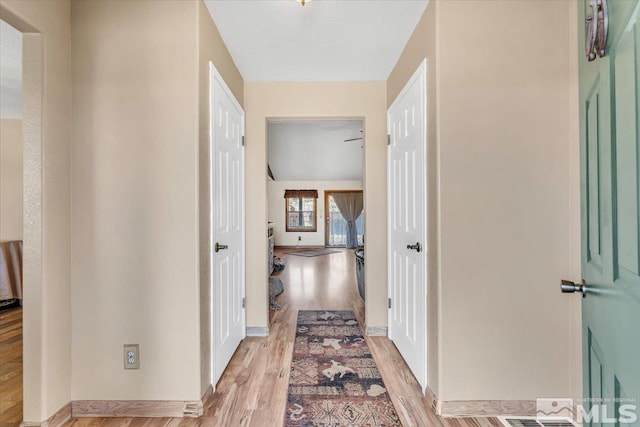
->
[387,61,427,389]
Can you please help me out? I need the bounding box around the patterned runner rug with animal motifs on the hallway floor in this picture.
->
[284,311,401,427]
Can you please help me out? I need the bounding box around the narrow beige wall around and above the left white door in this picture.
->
[198,1,244,394]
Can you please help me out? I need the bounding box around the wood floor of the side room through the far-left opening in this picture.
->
[0,307,22,427]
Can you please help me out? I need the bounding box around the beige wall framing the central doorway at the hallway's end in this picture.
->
[244,81,387,327]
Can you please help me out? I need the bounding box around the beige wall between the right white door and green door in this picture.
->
[388,0,580,401]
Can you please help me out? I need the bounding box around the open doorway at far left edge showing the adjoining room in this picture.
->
[0,20,24,426]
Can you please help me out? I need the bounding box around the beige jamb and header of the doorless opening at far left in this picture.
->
[0,11,46,424]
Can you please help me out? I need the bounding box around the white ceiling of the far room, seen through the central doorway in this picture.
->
[268,120,363,181]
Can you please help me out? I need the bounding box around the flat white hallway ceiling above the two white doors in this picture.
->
[205,0,428,81]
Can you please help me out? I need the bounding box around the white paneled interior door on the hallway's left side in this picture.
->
[209,64,245,385]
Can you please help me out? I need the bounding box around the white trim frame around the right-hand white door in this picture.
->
[387,58,430,391]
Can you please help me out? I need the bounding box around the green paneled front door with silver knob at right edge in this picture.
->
[578,0,640,426]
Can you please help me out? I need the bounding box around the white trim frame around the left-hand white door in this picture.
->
[208,61,247,391]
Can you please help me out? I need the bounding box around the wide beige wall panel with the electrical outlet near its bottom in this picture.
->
[71,1,201,400]
